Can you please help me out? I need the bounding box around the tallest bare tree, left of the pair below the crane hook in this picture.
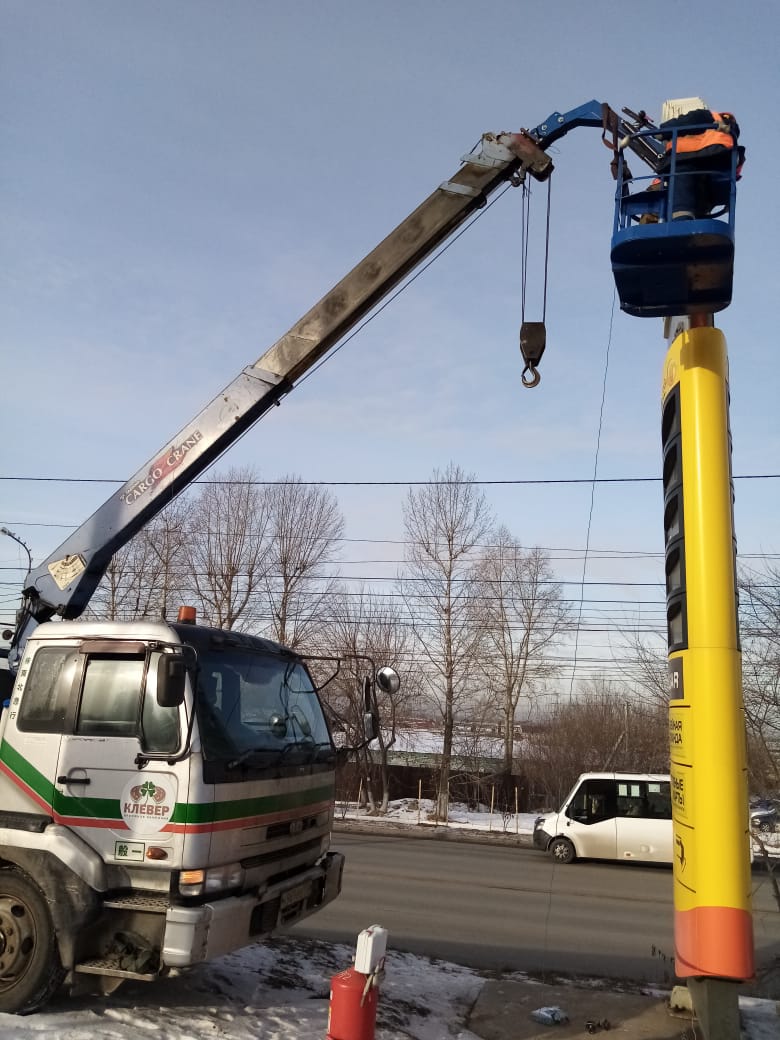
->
[400,463,492,817]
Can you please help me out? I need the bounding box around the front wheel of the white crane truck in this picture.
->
[0,869,64,1014]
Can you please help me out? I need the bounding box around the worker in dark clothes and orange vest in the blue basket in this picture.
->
[659,108,745,220]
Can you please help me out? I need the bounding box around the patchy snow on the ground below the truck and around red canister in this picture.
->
[0,936,484,1040]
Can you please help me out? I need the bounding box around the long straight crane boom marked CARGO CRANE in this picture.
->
[16,126,552,644]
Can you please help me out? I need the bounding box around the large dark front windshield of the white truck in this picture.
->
[196,647,333,770]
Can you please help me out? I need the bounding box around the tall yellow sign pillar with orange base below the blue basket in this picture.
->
[661,326,754,980]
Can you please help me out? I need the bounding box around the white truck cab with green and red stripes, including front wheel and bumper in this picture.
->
[0,621,351,1012]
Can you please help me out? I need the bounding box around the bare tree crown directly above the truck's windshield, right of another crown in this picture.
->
[263,476,344,648]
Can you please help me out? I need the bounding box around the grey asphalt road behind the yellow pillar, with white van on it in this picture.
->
[293,833,780,984]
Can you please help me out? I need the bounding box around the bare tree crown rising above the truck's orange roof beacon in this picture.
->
[185,469,270,630]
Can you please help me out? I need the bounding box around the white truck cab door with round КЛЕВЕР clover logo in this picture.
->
[55,641,186,868]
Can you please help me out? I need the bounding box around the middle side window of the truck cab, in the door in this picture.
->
[76,655,145,736]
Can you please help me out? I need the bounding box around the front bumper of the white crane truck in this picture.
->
[162,852,344,967]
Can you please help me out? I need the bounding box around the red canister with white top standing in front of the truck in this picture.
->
[326,925,387,1040]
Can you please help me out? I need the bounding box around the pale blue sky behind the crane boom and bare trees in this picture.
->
[0,0,780,686]
